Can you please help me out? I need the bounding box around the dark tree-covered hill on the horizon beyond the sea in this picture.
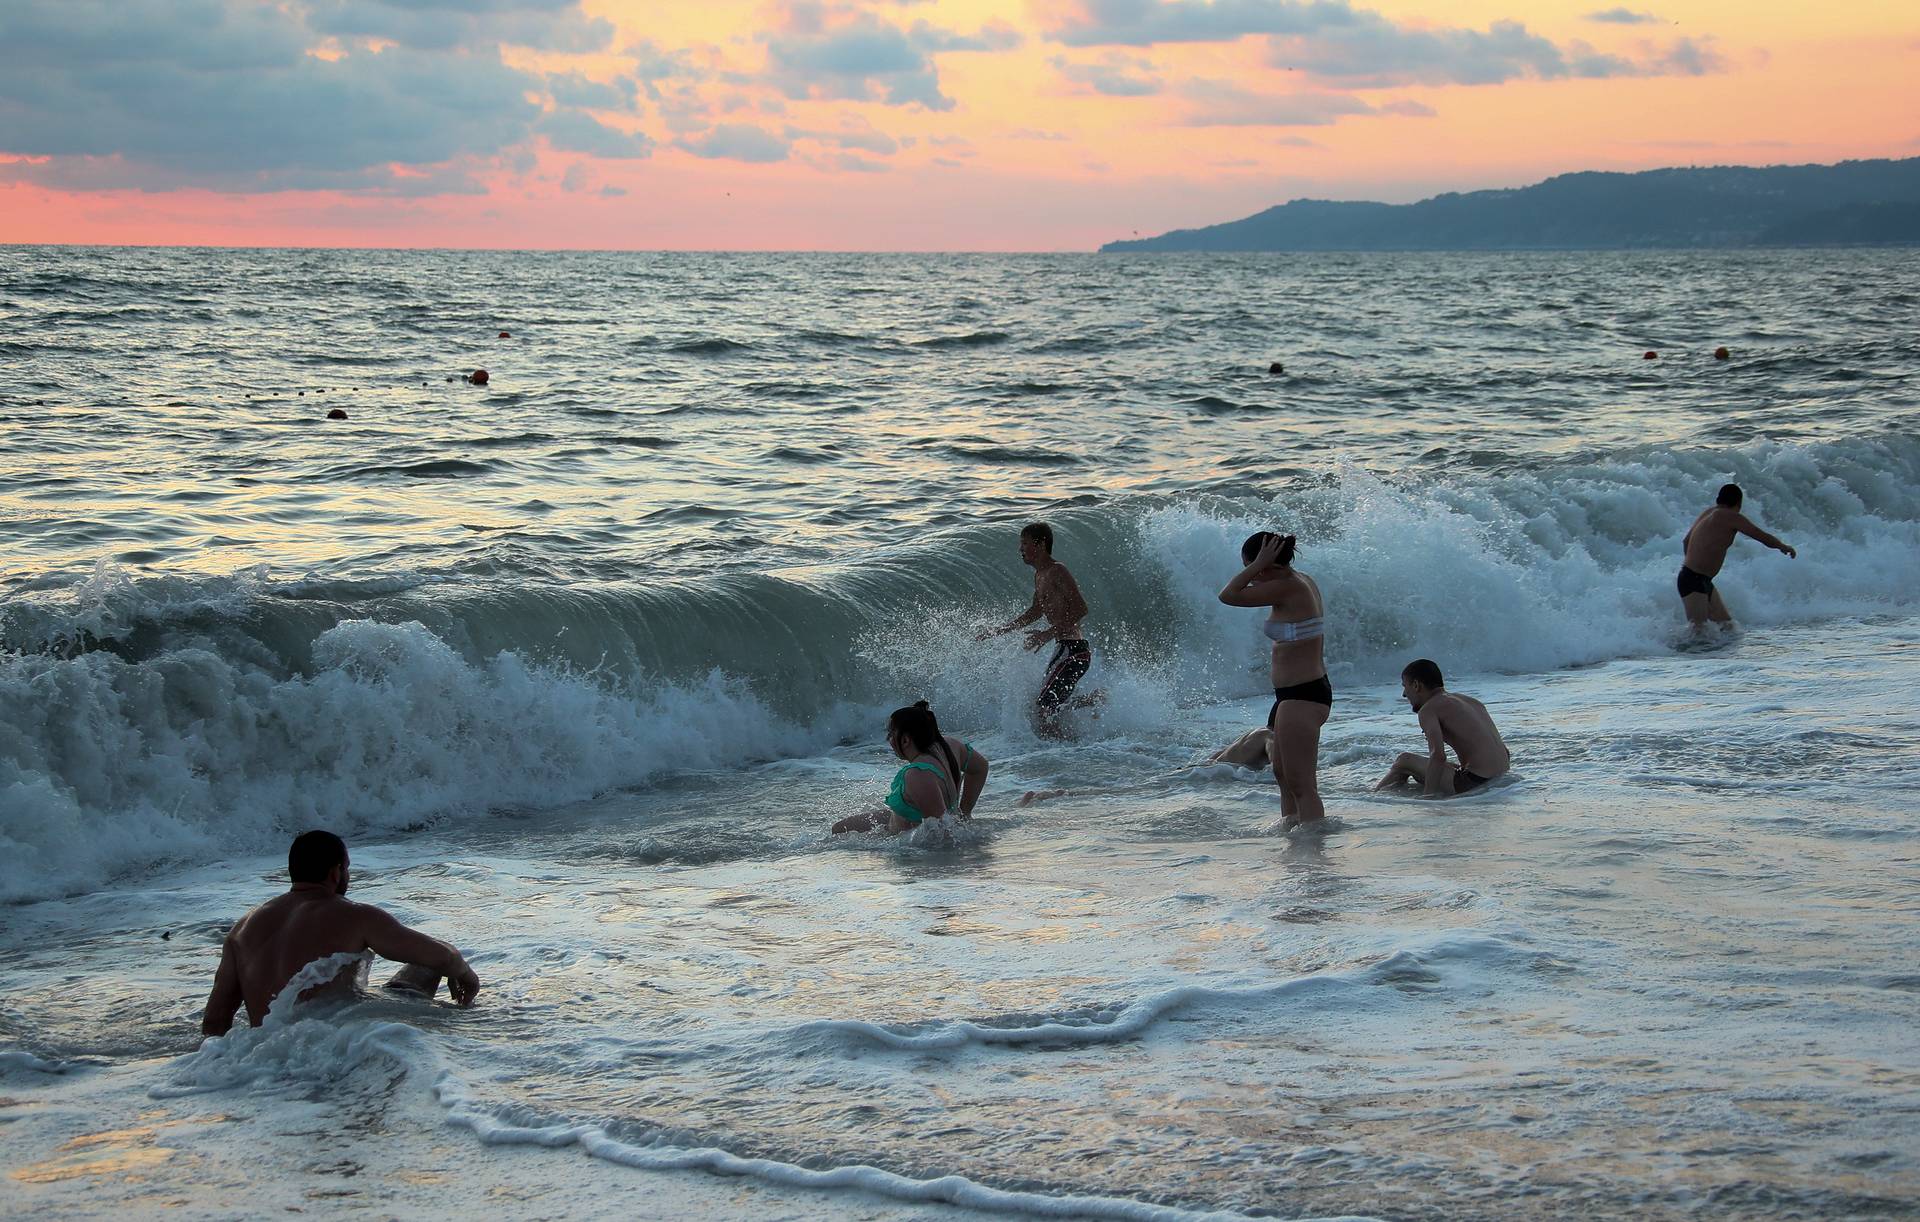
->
[1100,158,1920,254]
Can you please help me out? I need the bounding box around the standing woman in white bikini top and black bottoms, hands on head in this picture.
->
[1219,530,1332,828]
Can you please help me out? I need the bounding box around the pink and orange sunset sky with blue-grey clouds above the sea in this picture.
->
[0,0,1920,250]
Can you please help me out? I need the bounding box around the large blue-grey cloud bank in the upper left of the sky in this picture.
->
[0,0,651,194]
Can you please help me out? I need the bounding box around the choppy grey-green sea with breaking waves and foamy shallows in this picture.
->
[0,246,1920,1220]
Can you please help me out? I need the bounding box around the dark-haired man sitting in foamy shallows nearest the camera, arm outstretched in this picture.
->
[200,832,480,1036]
